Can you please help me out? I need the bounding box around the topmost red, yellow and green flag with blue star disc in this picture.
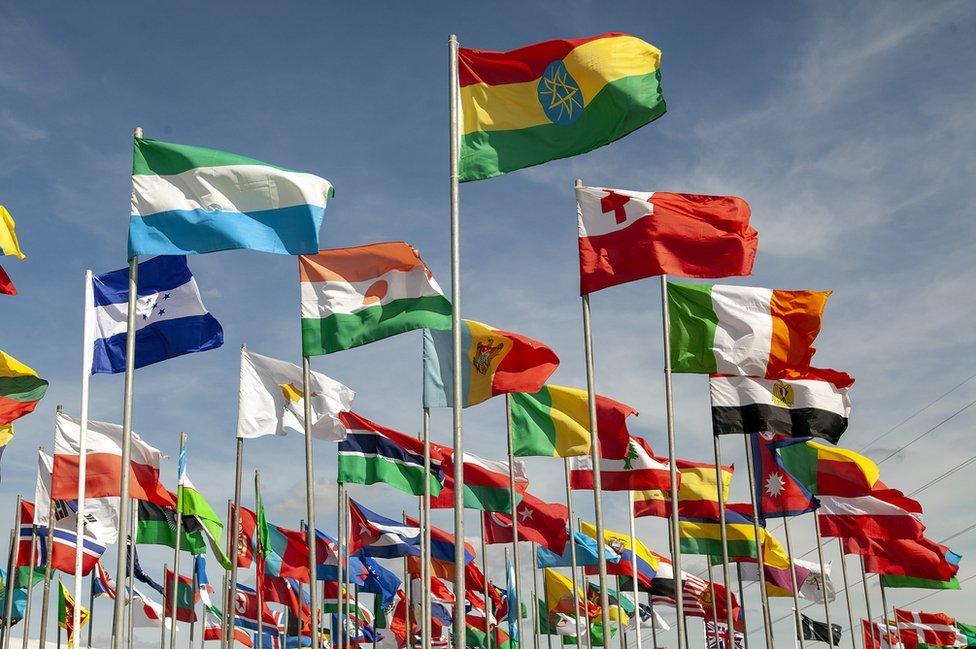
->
[458,33,666,182]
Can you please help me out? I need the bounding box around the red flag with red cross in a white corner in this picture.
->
[576,187,759,295]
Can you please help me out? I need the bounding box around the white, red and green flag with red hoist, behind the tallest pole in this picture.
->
[430,452,529,514]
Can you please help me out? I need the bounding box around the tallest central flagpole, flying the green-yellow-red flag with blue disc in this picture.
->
[448,34,465,649]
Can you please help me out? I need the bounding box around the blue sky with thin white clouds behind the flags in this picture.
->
[0,1,976,645]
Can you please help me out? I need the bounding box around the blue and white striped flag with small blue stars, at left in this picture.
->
[86,256,224,374]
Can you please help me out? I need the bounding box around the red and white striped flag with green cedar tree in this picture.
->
[569,436,681,493]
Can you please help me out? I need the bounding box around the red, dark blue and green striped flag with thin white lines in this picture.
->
[337,412,441,496]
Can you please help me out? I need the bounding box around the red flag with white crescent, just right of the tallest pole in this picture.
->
[482,492,569,555]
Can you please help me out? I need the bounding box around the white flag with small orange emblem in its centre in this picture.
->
[237,349,356,442]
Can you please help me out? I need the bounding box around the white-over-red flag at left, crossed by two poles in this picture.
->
[51,412,176,507]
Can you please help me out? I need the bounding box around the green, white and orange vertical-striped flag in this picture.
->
[668,282,830,379]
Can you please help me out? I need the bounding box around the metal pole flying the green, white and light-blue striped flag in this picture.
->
[113,126,143,649]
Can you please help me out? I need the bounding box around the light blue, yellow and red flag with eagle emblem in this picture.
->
[423,320,559,408]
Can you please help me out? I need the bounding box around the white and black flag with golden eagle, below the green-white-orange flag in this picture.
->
[708,376,851,444]
